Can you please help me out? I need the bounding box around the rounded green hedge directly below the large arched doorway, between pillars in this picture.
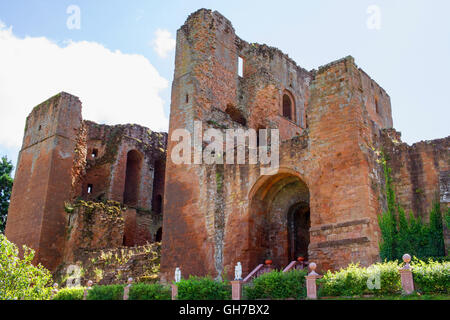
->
[244,270,307,300]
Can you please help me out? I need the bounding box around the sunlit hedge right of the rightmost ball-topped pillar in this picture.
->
[411,259,450,294]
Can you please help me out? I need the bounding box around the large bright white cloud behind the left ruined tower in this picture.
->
[0,22,168,147]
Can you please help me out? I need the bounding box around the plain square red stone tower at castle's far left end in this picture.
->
[6,92,82,270]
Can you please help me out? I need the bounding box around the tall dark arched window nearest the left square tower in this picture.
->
[123,150,142,206]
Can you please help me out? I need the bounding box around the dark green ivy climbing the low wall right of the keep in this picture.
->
[378,157,447,261]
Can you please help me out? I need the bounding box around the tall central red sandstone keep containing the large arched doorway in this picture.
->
[161,9,449,279]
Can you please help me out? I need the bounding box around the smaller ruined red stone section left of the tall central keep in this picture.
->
[6,92,167,271]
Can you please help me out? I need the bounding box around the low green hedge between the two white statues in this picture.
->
[177,276,231,300]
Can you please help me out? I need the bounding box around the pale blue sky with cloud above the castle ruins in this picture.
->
[0,0,450,170]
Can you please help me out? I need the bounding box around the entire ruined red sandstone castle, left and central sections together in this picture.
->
[6,9,450,281]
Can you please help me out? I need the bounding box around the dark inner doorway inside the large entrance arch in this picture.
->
[287,202,311,261]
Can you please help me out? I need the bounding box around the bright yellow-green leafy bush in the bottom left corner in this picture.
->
[0,234,52,300]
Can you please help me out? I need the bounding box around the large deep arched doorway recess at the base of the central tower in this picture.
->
[247,171,310,269]
